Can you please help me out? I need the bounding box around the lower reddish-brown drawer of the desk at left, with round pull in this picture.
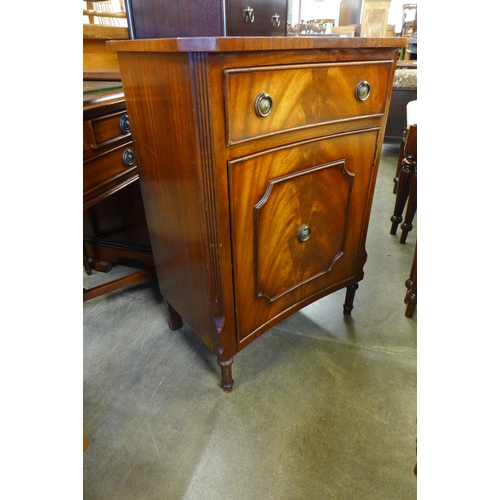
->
[83,142,137,200]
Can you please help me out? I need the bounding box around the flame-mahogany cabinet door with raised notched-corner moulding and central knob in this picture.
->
[228,129,379,346]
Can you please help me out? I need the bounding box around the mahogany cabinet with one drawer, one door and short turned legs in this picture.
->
[108,36,405,392]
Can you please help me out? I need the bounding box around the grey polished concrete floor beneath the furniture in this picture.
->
[83,145,418,500]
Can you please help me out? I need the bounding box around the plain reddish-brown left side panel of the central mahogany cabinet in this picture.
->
[119,53,213,348]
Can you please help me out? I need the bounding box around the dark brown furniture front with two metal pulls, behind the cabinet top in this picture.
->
[229,0,287,36]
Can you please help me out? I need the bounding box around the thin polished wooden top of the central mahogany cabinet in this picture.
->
[107,36,406,52]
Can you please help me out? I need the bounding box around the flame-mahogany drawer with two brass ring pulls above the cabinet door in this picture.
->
[224,61,391,145]
